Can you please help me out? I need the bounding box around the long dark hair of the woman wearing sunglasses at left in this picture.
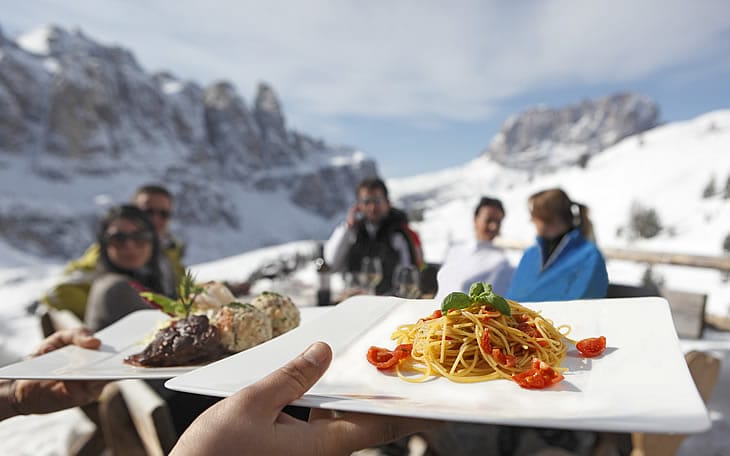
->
[96,204,162,293]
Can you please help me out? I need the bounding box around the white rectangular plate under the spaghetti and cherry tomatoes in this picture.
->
[166,296,710,433]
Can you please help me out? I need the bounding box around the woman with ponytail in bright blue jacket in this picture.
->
[506,188,608,302]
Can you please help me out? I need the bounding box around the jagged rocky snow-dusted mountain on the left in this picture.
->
[0,27,377,261]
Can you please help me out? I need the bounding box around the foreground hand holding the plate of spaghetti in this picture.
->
[171,342,438,456]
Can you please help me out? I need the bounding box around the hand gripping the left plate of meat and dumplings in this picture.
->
[11,328,108,414]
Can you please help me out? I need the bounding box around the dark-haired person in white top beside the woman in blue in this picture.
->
[435,197,514,302]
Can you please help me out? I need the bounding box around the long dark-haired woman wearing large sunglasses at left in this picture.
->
[85,205,163,331]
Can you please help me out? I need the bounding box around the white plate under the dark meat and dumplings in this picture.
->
[0,307,327,380]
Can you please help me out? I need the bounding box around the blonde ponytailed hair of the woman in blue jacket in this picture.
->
[527,188,596,241]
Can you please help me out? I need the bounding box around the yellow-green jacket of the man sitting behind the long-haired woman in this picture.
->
[41,239,185,321]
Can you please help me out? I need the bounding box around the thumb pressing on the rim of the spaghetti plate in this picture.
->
[242,342,332,419]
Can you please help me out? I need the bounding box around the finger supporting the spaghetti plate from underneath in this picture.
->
[323,413,443,454]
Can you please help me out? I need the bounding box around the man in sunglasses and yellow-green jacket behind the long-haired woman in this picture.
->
[41,185,185,320]
